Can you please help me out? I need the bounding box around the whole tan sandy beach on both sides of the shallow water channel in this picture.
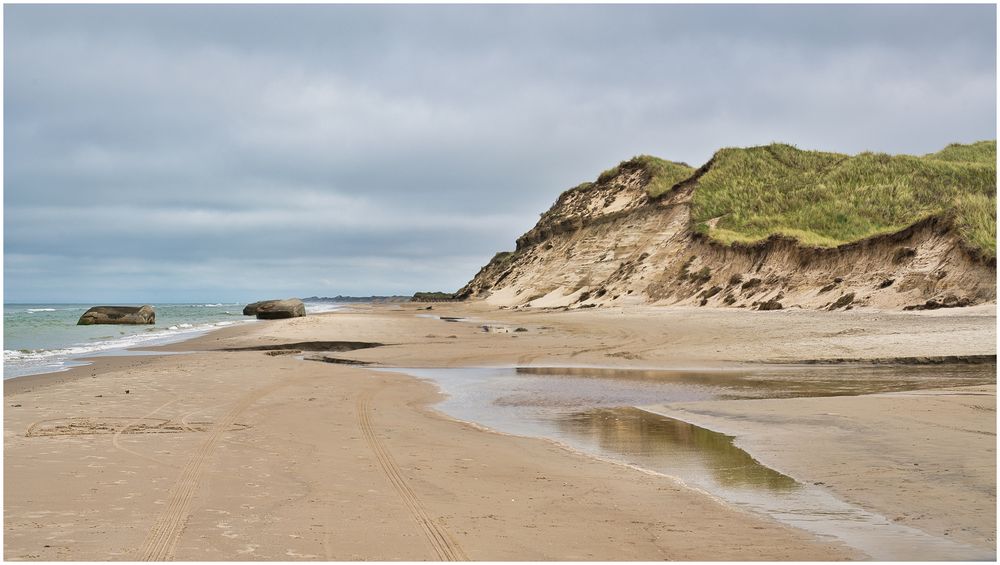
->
[4,303,996,561]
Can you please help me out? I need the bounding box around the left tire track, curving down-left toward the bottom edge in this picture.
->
[138,381,290,561]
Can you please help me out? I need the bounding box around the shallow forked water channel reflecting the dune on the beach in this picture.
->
[380,365,996,560]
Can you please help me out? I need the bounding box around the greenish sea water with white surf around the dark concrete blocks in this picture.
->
[3,302,338,379]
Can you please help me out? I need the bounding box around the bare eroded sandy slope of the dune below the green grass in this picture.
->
[458,159,996,309]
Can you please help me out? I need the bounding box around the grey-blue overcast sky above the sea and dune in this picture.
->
[4,5,997,303]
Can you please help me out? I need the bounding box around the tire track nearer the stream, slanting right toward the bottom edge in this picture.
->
[356,390,469,561]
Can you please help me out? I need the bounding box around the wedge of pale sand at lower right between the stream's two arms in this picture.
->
[647,384,997,559]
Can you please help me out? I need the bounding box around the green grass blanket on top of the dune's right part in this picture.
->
[692,140,997,259]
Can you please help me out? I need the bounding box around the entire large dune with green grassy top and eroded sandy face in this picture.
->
[456,140,996,310]
